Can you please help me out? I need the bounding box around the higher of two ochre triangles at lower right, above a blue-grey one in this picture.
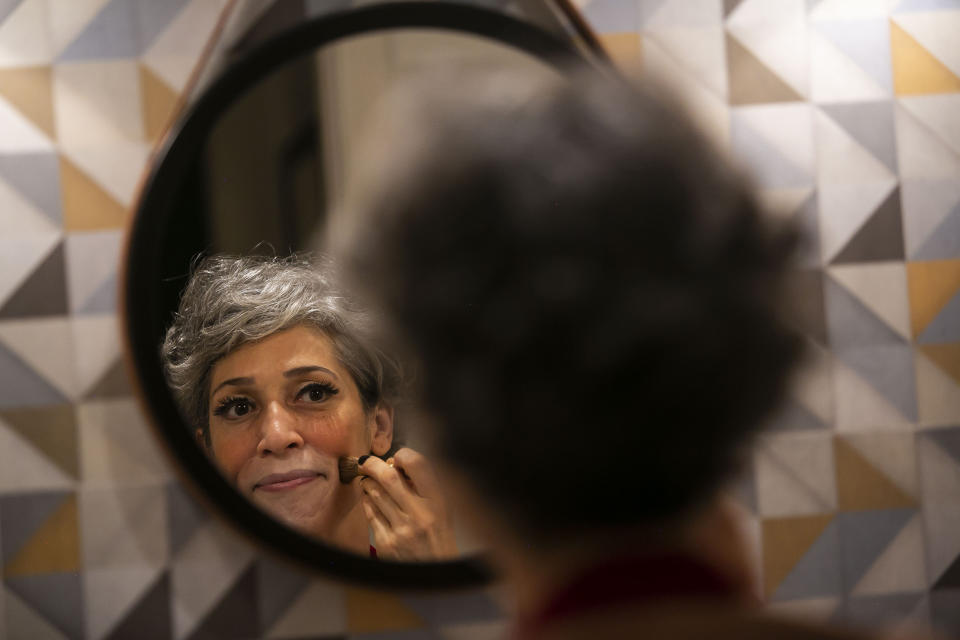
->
[833,438,917,511]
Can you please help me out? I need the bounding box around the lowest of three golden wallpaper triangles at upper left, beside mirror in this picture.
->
[60,156,127,231]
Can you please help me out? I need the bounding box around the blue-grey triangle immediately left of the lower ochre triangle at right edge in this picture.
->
[836,343,917,420]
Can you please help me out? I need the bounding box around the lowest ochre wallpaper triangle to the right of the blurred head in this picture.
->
[762,513,833,597]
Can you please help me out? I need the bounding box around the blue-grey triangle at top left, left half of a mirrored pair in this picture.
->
[58,0,141,61]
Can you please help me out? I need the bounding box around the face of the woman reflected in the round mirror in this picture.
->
[209,326,393,553]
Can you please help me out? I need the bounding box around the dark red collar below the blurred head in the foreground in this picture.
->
[514,552,739,640]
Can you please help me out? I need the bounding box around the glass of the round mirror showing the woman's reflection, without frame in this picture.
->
[151,30,556,561]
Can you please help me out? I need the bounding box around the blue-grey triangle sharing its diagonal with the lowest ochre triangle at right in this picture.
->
[771,520,843,601]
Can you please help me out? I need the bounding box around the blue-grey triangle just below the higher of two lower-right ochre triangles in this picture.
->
[837,509,917,588]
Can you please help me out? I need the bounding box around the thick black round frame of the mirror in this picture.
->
[120,0,589,589]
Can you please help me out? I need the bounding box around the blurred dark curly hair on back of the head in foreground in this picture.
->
[335,72,802,534]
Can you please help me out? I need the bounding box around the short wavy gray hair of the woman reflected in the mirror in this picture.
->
[160,254,402,437]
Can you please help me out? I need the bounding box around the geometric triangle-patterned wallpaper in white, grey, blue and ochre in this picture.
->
[0,0,960,640]
